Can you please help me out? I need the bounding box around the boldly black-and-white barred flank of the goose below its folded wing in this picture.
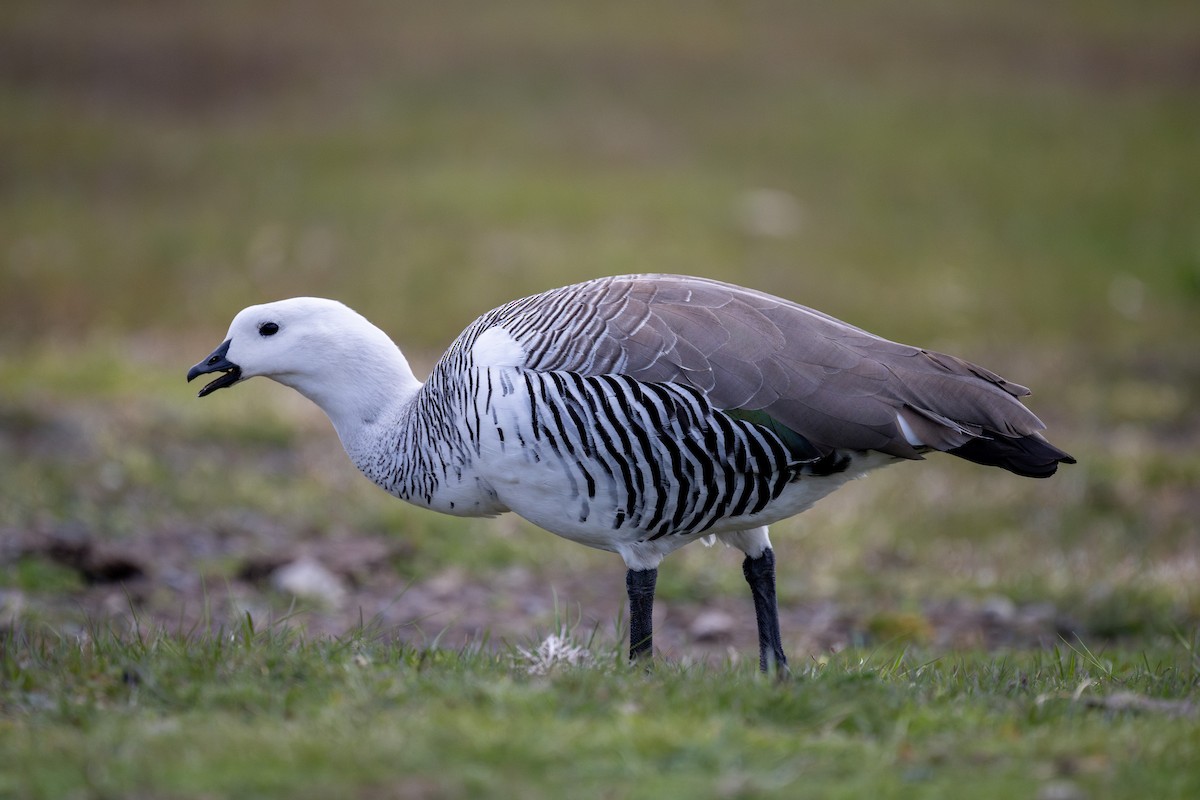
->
[479,368,804,540]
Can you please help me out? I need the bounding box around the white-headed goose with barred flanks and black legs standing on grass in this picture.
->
[187,275,1075,674]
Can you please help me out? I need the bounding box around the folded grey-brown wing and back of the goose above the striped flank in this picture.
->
[478,275,1069,471]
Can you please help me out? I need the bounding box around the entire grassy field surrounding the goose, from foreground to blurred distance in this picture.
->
[0,0,1200,800]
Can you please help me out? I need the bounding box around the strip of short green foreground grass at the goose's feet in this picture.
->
[0,624,1200,798]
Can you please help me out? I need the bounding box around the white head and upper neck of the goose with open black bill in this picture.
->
[187,297,420,441]
